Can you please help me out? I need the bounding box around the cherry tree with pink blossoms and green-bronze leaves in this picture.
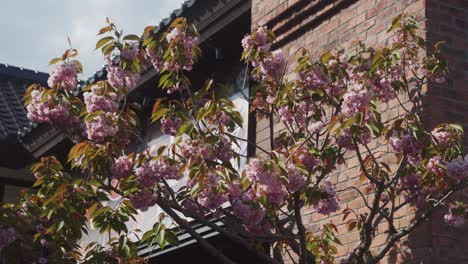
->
[0,15,468,264]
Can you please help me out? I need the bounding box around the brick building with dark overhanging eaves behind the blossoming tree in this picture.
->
[2,0,468,264]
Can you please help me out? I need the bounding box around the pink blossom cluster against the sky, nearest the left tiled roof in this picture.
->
[47,61,78,91]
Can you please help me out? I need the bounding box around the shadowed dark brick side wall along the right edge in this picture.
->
[426,0,468,264]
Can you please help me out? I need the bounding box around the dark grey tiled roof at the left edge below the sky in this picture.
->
[0,63,49,140]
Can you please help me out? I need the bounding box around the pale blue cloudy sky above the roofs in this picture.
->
[0,0,183,80]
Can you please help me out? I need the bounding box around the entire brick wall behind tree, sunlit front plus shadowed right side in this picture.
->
[252,0,468,263]
